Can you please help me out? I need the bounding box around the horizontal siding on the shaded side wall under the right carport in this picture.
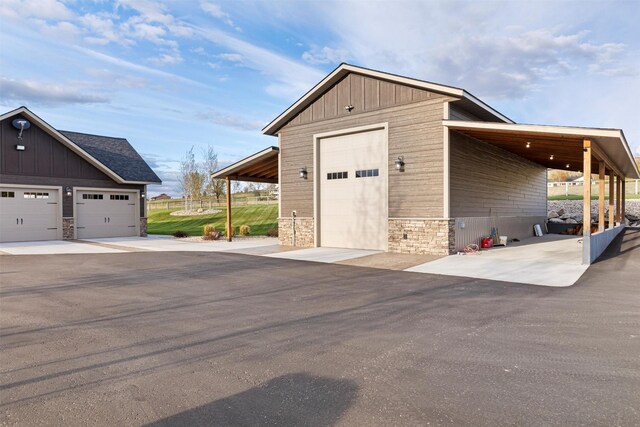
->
[449,131,547,217]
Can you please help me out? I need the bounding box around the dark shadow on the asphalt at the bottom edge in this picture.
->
[148,373,358,427]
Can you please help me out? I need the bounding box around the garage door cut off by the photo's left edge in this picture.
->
[0,187,62,242]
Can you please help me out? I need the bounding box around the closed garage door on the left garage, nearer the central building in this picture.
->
[76,190,138,239]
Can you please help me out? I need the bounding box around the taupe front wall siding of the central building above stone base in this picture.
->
[280,74,453,218]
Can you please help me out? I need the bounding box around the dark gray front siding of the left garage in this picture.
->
[0,116,145,217]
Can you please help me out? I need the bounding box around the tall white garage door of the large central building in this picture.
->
[319,130,388,250]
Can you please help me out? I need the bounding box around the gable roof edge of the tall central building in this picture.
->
[262,63,514,135]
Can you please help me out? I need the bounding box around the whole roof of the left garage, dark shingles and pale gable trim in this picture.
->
[0,106,162,184]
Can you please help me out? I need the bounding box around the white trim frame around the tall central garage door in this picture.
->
[313,122,389,252]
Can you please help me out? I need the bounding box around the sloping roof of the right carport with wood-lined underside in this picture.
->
[442,120,640,179]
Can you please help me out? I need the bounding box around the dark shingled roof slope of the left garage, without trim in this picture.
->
[59,130,162,183]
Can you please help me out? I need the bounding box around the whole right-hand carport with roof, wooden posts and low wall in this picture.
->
[443,120,640,265]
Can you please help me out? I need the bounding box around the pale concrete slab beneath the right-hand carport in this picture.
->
[405,235,588,287]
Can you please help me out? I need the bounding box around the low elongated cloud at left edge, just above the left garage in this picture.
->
[0,77,109,105]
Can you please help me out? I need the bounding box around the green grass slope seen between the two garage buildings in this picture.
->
[148,204,278,236]
